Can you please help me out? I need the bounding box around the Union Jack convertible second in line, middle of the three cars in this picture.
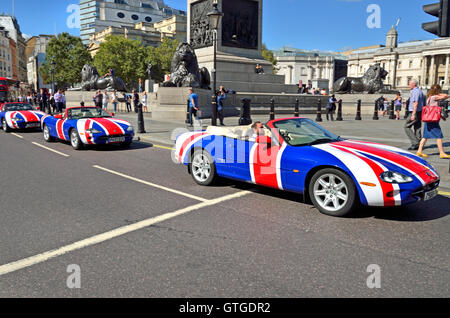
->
[41,107,134,150]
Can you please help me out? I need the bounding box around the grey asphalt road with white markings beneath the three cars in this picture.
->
[0,128,450,298]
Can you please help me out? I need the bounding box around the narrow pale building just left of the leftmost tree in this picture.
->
[26,34,54,91]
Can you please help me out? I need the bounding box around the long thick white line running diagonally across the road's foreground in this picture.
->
[0,191,251,276]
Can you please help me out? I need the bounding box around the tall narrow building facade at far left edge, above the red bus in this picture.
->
[0,15,27,82]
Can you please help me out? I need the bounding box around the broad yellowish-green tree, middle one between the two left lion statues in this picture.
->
[94,35,148,88]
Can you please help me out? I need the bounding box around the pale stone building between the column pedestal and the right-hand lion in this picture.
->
[274,47,348,90]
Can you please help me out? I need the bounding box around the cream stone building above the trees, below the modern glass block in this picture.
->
[88,15,186,57]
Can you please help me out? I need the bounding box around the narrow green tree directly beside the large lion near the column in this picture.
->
[147,38,179,83]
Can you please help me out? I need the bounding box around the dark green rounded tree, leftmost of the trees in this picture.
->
[39,33,92,87]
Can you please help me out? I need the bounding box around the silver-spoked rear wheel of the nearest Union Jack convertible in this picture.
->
[189,149,217,186]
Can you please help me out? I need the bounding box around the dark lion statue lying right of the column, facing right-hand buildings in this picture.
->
[333,63,388,94]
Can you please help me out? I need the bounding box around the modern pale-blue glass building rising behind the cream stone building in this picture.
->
[80,0,186,45]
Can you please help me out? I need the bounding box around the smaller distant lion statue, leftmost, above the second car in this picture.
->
[81,64,127,92]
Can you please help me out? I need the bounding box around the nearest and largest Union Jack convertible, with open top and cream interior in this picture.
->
[174,118,440,216]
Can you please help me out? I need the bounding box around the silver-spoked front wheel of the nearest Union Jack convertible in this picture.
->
[309,168,358,217]
